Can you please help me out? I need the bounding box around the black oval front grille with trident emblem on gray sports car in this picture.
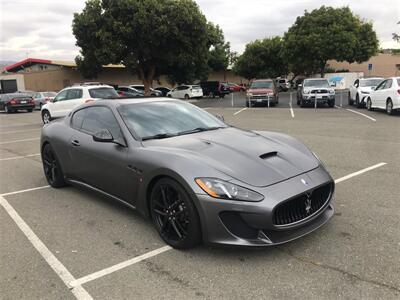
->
[274,183,333,225]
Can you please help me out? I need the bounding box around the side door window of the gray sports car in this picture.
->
[82,106,121,139]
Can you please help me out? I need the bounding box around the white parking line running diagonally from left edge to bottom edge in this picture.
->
[0,196,93,300]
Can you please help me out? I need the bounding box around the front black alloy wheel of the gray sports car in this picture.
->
[150,178,201,249]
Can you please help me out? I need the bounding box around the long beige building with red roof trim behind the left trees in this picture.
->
[0,58,247,93]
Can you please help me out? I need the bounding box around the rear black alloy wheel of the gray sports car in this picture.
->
[42,144,66,188]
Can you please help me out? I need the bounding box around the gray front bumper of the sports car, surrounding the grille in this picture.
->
[197,167,334,246]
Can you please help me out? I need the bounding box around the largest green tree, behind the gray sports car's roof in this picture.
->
[72,0,220,94]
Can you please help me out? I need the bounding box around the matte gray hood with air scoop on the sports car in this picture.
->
[143,127,319,187]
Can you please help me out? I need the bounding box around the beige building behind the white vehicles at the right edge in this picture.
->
[328,53,400,77]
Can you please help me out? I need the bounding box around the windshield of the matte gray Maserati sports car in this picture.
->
[118,101,227,139]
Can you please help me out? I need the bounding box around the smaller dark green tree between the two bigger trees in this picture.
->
[233,37,288,79]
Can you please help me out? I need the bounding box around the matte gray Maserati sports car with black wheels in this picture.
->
[41,98,334,248]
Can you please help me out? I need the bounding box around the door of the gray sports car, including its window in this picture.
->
[69,106,133,200]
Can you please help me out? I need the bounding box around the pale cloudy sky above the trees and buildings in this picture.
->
[0,0,400,61]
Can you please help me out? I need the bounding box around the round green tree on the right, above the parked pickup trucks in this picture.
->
[284,6,379,75]
